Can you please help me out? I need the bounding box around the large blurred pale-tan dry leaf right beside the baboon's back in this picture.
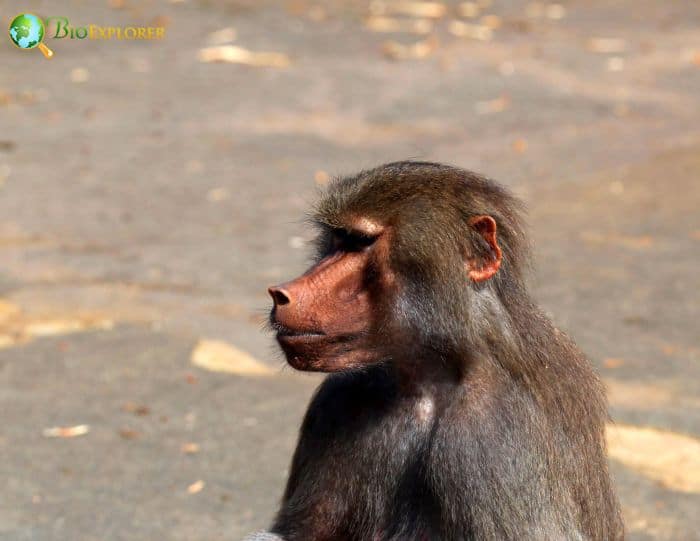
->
[607,425,700,494]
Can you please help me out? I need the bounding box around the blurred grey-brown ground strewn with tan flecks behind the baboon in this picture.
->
[0,0,700,541]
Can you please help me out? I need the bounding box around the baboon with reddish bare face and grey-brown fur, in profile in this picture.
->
[269,161,624,541]
